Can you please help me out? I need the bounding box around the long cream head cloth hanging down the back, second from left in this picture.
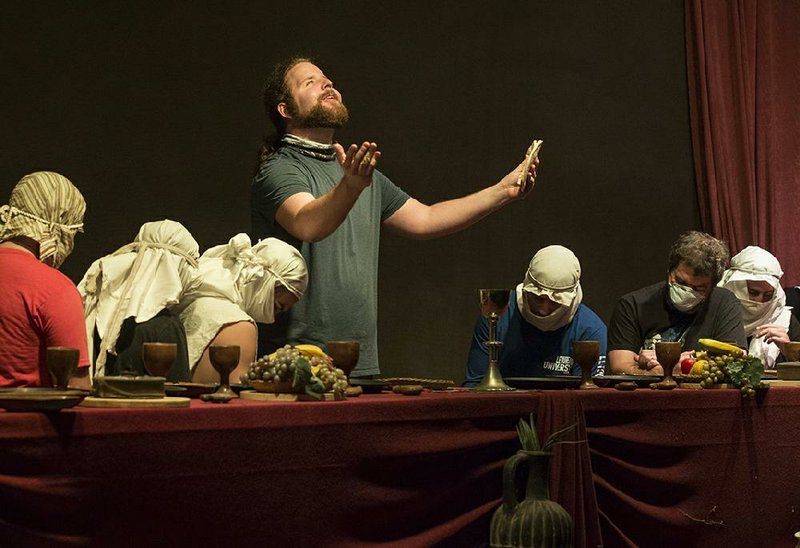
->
[78,220,200,375]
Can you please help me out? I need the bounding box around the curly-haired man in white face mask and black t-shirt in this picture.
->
[608,231,746,375]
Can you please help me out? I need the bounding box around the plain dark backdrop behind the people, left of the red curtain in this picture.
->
[0,0,699,379]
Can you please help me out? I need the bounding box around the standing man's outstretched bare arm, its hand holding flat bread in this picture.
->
[384,158,539,239]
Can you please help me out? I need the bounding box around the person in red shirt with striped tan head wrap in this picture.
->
[0,171,91,388]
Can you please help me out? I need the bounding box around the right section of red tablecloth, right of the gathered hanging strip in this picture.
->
[580,386,800,548]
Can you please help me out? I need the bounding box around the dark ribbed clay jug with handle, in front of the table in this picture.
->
[489,451,574,547]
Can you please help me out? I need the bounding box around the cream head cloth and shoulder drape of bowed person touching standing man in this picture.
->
[180,234,308,367]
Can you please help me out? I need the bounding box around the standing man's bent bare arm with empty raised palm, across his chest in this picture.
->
[275,142,381,242]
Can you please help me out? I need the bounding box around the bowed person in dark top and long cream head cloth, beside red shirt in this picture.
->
[78,219,200,382]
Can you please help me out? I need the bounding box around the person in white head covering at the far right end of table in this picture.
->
[718,245,800,369]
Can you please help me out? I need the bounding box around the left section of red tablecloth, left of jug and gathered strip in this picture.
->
[0,392,536,546]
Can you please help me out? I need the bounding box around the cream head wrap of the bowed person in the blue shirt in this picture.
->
[517,245,583,331]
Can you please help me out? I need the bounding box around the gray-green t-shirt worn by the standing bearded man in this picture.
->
[251,145,409,377]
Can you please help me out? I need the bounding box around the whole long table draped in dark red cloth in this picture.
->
[0,387,800,547]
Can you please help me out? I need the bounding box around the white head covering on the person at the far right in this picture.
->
[717,245,791,368]
